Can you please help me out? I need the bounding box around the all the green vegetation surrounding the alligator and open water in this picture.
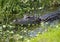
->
[0,0,60,42]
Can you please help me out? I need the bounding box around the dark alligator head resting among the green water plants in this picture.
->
[13,16,41,25]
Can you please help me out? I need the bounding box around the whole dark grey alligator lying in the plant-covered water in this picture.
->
[13,11,60,25]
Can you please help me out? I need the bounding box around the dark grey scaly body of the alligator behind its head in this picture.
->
[39,11,60,22]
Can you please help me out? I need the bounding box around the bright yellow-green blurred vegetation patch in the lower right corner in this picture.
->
[30,26,60,42]
